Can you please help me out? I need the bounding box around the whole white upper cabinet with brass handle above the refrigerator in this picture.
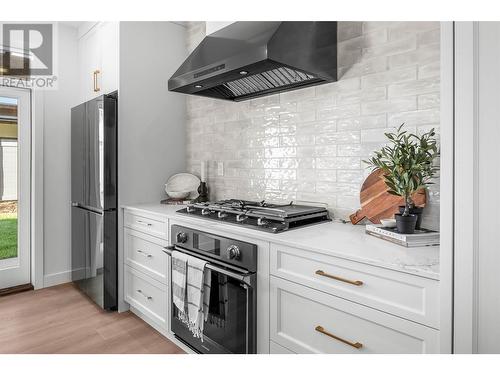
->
[78,22,119,102]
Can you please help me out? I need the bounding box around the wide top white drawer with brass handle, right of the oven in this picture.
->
[270,244,439,328]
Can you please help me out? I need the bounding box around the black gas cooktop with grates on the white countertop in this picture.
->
[177,199,330,233]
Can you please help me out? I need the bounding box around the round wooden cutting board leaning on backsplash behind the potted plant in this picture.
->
[350,169,427,224]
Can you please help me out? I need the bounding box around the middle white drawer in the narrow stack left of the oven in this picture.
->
[124,228,167,284]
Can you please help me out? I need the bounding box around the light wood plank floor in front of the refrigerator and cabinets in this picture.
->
[0,284,183,354]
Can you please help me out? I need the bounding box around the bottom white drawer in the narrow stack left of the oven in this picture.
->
[124,265,167,327]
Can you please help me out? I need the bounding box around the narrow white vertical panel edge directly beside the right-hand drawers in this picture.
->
[439,22,454,353]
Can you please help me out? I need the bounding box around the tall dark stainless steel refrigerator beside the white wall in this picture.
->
[71,93,118,309]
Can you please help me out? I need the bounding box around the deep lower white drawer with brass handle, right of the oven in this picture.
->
[270,276,439,354]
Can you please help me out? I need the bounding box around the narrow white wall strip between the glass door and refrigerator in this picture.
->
[42,24,78,287]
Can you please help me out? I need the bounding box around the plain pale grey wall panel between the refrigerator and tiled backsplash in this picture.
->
[118,22,187,309]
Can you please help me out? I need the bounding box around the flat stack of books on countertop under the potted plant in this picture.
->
[366,224,439,247]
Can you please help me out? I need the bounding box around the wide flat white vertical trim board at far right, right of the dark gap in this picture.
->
[454,22,478,353]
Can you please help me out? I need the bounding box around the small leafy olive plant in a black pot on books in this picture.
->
[364,123,439,233]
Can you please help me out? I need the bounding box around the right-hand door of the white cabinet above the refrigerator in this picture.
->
[99,22,119,94]
